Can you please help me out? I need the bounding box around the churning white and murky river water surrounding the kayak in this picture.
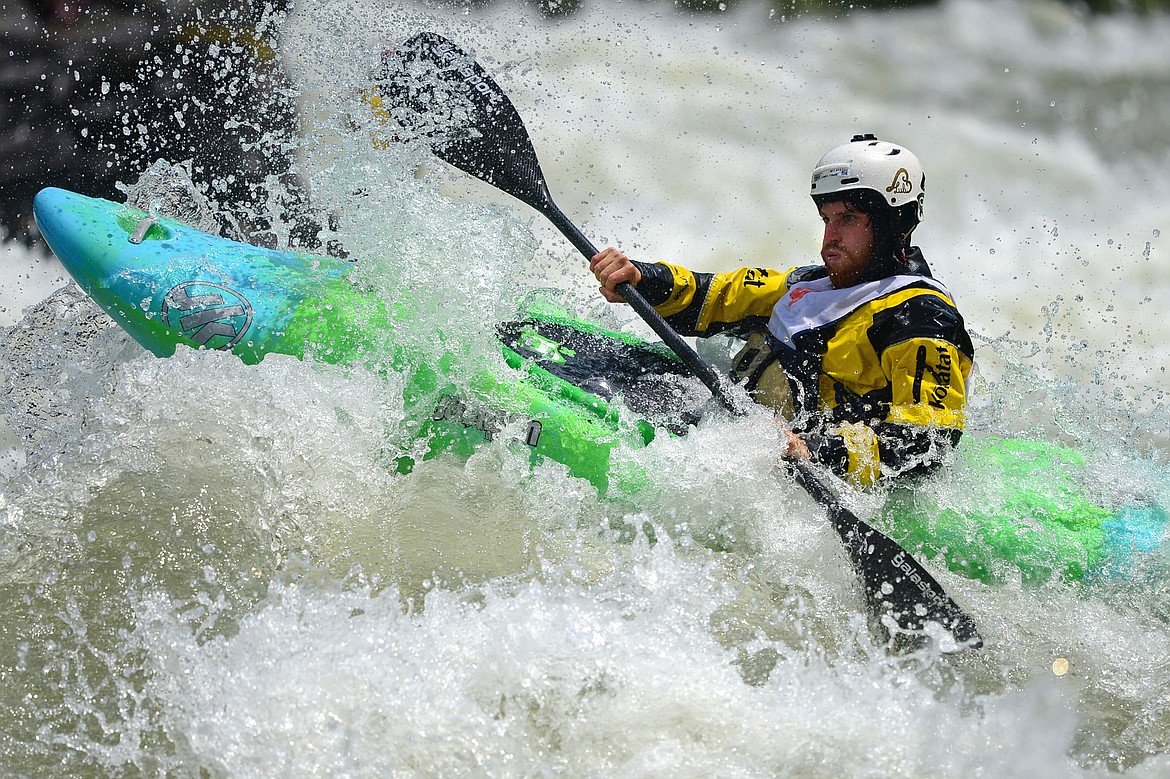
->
[0,0,1170,778]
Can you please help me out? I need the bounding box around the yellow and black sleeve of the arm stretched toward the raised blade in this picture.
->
[634,261,787,336]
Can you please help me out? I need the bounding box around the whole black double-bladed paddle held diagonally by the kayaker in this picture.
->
[369,33,983,648]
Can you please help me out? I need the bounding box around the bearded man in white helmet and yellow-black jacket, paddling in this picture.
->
[590,135,973,484]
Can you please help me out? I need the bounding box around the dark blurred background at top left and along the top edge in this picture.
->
[0,0,1170,248]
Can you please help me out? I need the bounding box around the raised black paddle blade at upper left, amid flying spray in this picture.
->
[367,33,555,213]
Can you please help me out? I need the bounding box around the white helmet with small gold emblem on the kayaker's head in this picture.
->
[812,133,927,225]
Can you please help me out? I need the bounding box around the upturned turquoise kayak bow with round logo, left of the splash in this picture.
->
[33,187,362,363]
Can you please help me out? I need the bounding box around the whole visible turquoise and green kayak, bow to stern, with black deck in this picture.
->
[34,188,1168,582]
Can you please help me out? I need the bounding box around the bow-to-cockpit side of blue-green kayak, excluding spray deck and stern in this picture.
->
[34,187,654,492]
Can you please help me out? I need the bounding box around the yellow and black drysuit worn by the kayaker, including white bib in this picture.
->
[635,248,973,484]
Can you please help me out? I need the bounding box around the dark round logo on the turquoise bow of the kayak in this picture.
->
[163,282,253,351]
